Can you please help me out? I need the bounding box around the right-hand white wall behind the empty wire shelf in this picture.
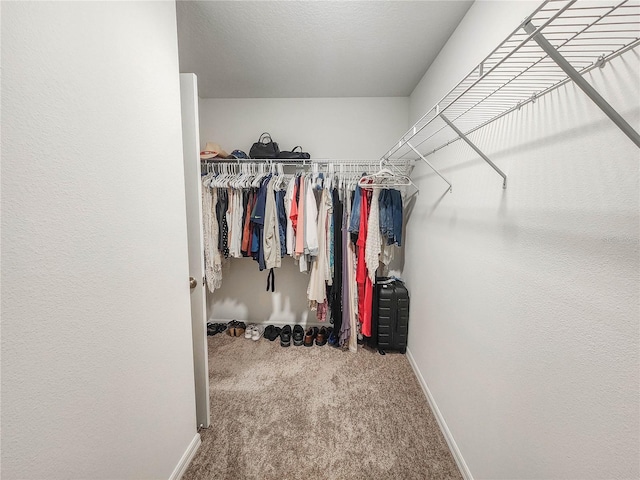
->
[405,2,640,479]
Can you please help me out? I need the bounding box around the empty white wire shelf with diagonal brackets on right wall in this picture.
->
[382,0,640,191]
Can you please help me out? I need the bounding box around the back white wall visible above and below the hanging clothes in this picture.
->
[200,97,409,324]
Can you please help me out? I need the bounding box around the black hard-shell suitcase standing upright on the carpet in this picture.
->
[371,277,409,355]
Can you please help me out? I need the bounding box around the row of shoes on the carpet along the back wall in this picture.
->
[207,320,338,347]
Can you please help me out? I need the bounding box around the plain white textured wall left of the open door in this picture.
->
[2,2,196,480]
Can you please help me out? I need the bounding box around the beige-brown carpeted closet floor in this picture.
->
[183,334,462,480]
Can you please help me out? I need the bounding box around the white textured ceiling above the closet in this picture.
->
[177,0,473,98]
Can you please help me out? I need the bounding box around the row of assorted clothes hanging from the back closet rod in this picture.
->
[202,161,410,351]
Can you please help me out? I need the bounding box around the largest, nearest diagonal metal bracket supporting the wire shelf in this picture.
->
[522,22,640,148]
